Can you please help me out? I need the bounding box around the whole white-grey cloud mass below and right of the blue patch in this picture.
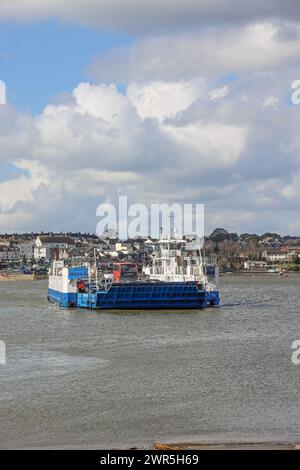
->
[0,17,300,232]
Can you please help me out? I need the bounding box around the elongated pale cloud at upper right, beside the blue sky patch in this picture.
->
[88,21,300,82]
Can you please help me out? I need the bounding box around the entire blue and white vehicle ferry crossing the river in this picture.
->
[48,236,220,310]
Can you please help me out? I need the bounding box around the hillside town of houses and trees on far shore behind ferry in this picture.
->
[0,228,300,274]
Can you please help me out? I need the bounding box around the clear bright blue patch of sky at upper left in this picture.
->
[0,20,133,114]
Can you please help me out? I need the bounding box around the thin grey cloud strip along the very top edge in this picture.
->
[0,0,300,33]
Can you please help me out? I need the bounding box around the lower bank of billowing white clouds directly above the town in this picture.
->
[0,70,299,235]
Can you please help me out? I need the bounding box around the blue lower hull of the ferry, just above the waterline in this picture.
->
[48,282,220,310]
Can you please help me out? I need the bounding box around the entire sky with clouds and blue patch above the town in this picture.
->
[0,0,300,235]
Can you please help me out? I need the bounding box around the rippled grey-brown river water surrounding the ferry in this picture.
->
[0,275,300,448]
